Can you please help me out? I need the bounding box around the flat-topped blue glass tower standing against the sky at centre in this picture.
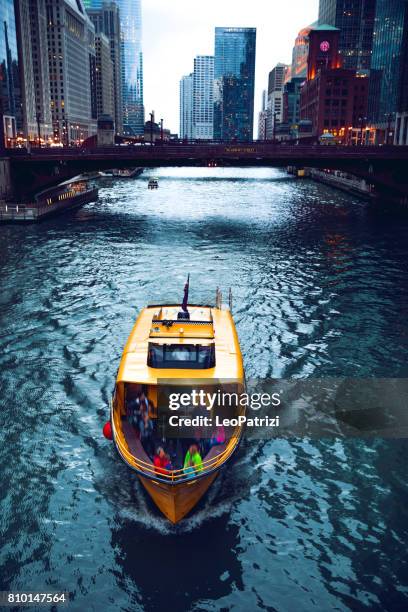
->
[214,28,256,141]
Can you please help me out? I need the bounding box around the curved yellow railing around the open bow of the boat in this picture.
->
[112,402,240,483]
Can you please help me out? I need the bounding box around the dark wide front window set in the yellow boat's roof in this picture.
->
[147,342,215,370]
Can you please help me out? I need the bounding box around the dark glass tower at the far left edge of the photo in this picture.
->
[0,0,23,146]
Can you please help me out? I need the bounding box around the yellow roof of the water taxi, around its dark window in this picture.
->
[117,304,244,384]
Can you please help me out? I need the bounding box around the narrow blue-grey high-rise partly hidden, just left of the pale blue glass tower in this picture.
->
[87,2,123,134]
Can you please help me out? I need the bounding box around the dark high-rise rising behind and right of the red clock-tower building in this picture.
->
[318,0,376,70]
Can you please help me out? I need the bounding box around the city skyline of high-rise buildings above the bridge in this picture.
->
[0,0,408,146]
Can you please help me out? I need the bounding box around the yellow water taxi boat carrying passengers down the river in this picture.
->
[105,281,245,523]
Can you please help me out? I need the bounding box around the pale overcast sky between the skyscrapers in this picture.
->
[142,0,319,132]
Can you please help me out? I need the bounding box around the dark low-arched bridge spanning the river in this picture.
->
[7,141,408,197]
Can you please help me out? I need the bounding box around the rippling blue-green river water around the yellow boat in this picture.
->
[0,168,408,612]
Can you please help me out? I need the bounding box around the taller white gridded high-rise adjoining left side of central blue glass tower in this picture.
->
[193,55,214,140]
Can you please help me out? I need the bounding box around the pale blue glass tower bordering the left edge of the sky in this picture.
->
[85,0,144,136]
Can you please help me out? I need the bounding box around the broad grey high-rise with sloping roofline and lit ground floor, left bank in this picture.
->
[46,0,96,144]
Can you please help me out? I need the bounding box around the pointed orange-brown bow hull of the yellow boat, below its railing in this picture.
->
[138,471,218,523]
